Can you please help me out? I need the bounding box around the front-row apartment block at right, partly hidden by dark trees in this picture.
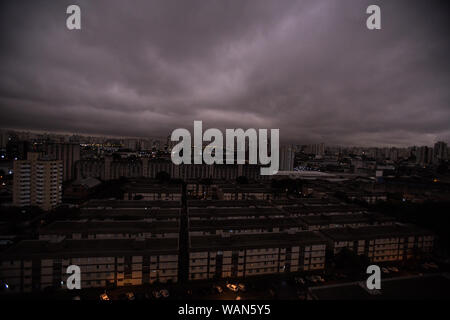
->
[321,224,434,263]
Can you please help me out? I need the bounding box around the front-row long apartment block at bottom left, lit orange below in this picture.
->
[0,239,178,292]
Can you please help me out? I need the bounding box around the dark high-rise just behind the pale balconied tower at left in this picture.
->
[47,143,80,181]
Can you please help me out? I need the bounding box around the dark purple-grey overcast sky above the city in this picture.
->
[0,0,450,146]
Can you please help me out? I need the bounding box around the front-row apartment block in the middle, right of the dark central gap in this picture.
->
[189,232,326,280]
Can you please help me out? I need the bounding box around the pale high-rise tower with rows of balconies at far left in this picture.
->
[13,152,63,210]
